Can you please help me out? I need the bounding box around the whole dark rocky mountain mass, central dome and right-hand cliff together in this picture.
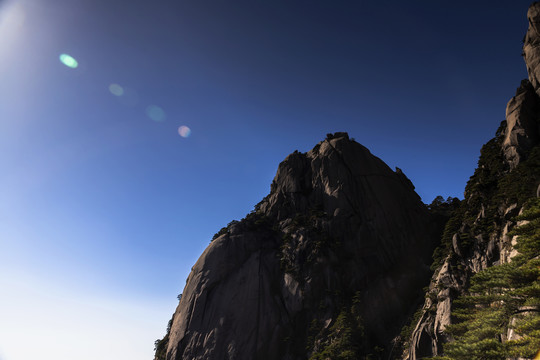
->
[155,3,540,360]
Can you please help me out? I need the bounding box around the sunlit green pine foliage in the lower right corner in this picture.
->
[437,199,540,360]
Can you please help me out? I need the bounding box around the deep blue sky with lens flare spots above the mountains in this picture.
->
[0,0,530,360]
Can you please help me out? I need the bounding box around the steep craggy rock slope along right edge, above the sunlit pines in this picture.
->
[403,3,540,360]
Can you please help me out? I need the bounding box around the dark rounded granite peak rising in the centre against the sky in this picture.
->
[160,133,437,360]
